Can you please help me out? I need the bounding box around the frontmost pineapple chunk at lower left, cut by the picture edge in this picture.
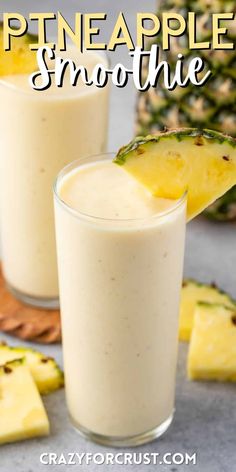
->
[0,359,49,444]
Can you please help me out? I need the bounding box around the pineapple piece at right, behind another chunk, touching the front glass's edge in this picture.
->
[179,280,236,341]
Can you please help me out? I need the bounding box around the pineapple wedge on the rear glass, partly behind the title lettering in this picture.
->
[0,23,37,76]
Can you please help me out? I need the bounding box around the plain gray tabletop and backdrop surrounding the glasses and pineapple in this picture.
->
[0,0,236,472]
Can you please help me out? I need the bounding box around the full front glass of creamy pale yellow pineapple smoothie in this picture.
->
[55,156,186,445]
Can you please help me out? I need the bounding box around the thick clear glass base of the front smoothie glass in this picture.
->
[70,412,174,447]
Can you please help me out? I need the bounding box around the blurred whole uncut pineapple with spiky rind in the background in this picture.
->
[136,0,236,221]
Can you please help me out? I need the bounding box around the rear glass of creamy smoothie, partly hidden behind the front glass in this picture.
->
[0,47,108,305]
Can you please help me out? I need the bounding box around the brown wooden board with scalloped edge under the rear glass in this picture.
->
[0,266,61,344]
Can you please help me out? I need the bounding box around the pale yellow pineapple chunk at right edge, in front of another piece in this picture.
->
[188,302,236,382]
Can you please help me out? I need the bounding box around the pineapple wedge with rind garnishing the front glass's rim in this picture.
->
[114,128,236,220]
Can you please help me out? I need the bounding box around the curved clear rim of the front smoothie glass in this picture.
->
[53,152,188,225]
